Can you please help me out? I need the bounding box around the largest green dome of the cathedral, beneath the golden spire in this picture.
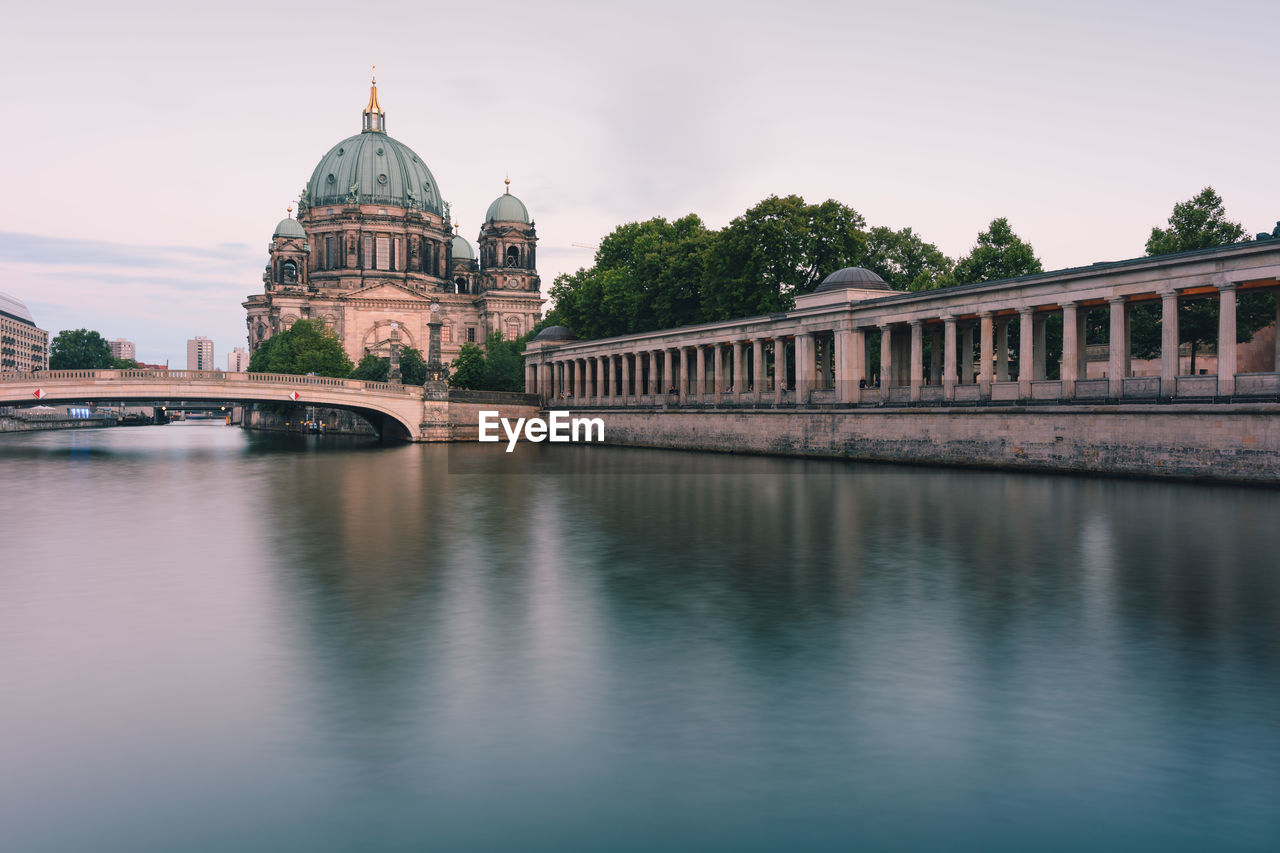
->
[306,131,440,214]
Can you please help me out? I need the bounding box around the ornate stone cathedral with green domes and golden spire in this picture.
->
[243,81,543,362]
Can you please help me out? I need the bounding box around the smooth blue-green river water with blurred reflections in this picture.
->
[0,424,1280,852]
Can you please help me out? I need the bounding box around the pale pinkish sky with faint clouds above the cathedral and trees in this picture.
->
[0,0,1280,368]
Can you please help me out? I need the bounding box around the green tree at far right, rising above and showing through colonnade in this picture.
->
[1130,187,1275,363]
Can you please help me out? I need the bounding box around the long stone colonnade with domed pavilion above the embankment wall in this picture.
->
[525,241,1280,406]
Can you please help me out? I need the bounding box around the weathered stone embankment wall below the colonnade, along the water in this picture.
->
[573,403,1280,484]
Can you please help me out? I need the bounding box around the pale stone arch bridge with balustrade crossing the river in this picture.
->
[0,370,430,441]
